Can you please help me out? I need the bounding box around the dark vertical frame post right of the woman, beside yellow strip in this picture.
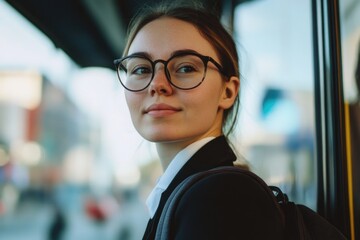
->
[312,0,350,237]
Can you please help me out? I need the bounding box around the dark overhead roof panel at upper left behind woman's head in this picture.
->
[6,0,226,68]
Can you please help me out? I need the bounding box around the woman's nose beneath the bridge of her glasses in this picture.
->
[149,64,173,95]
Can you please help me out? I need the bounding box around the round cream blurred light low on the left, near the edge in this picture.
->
[18,142,43,166]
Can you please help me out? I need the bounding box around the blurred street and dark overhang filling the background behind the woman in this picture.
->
[0,0,360,240]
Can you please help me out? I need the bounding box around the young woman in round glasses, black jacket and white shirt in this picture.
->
[115,2,281,240]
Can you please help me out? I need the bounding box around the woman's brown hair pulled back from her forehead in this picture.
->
[123,3,240,135]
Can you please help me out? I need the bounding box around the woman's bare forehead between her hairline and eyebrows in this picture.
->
[128,17,217,59]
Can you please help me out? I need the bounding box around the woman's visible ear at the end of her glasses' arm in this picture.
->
[219,77,240,110]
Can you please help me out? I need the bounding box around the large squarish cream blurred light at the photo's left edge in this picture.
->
[0,71,42,109]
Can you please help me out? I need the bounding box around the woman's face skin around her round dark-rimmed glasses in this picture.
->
[125,18,235,143]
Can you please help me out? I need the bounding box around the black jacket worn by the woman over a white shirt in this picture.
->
[143,136,283,240]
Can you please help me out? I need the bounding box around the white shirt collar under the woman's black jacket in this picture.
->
[146,137,215,218]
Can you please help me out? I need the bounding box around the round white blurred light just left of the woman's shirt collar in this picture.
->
[115,165,141,187]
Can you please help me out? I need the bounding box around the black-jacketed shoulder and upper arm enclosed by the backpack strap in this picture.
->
[175,171,282,239]
